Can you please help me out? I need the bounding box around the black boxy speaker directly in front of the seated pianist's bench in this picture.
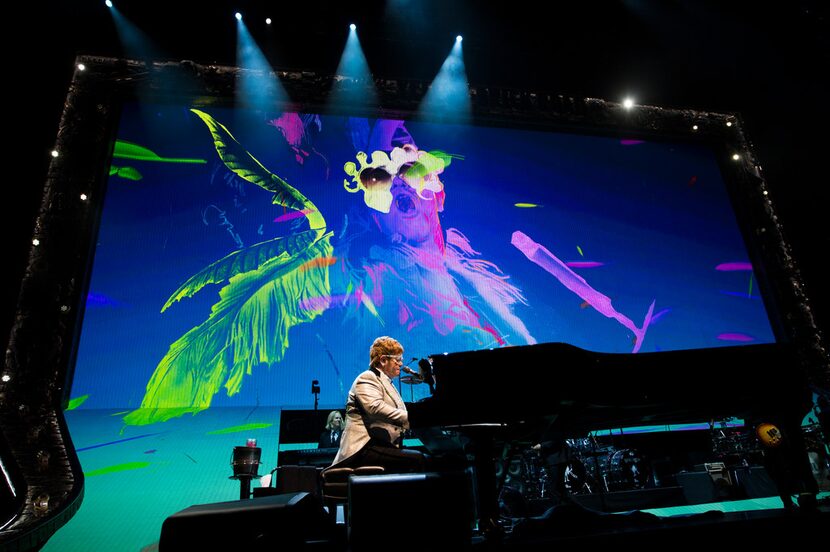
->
[349,472,474,550]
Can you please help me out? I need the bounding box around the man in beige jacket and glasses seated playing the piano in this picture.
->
[331,336,424,473]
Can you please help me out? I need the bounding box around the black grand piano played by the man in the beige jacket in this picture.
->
[407,343,811,534]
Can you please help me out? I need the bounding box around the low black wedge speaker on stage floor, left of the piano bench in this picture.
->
[159,492,328,552]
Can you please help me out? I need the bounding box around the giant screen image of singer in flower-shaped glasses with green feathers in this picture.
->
[45,105,775,550]
